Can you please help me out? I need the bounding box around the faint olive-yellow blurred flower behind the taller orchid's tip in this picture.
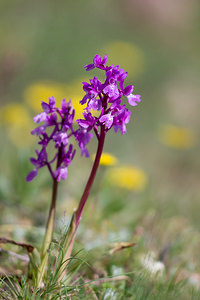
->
[101,41,145,77]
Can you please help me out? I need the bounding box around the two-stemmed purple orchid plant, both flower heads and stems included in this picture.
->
[26,55,141,287]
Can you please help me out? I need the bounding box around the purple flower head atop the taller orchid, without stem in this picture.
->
[77,55,141,137]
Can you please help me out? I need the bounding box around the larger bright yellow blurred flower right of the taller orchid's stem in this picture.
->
[107,166,147,191]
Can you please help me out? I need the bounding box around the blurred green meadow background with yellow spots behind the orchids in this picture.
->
[0,0,200,300]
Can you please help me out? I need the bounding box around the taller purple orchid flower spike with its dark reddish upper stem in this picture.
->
[76,54,140,226]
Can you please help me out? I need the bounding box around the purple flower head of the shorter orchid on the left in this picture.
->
[26,97,91,181]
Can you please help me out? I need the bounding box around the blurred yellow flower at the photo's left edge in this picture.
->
[0,103,34,148]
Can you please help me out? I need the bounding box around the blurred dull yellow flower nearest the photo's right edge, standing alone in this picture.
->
[159,125,196,149]
